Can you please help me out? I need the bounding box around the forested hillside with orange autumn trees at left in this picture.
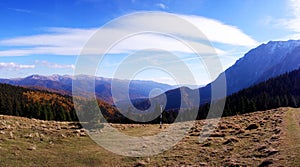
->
[0,84,117,121]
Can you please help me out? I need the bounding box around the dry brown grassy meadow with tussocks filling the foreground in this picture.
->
[0,108,300,166]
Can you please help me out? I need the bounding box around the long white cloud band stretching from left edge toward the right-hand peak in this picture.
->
[0,12,257,56]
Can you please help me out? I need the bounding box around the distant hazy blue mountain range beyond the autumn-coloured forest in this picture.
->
[0,75,174,104]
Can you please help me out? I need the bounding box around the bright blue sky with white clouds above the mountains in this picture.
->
[0,0,300,85]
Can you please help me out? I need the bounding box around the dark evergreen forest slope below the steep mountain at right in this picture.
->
[198,68,300,119]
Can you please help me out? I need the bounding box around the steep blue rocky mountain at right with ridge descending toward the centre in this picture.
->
[134,40,300,109]
